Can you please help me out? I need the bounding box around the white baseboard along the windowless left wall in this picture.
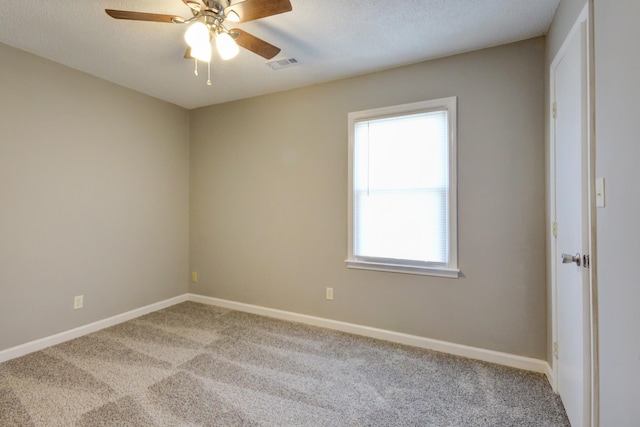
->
[0,294,189,363]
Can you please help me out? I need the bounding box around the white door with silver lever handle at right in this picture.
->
[551,8,591,427]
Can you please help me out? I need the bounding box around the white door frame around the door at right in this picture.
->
[547,0,599,427]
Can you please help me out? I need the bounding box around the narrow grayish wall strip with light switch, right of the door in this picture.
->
[594,0,640,427]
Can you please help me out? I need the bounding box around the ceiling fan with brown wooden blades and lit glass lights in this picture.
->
[105,0,293,85]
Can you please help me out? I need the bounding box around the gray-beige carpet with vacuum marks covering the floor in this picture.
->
[0,302,569,426]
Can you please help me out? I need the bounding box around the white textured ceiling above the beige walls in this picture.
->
[0,0,559,108]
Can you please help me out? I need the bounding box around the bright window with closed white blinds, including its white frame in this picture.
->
[347,97,459,277]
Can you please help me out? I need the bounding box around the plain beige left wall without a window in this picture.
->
[0,44,189,350]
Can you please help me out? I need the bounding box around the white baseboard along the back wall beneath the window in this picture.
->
[189,294,552,381]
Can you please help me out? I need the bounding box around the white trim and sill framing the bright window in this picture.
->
[345,96,460,278]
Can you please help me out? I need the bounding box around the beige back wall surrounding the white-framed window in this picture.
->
[190,38,547,358]
